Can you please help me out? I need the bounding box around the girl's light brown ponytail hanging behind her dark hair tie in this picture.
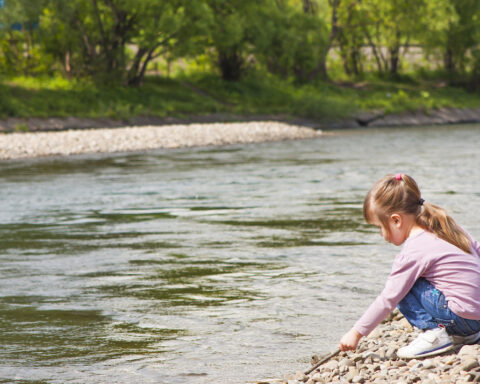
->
[416,202,472,253]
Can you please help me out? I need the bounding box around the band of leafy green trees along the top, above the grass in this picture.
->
[0,0,480,93]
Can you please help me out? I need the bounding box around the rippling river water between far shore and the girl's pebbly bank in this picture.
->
[0,126,480,384]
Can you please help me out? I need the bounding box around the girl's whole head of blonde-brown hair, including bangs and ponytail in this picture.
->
[363,174,471,253]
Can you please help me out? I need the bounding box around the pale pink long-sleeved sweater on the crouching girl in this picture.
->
[354,231,480,336]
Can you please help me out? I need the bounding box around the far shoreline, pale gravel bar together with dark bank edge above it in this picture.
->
[0,108,480,160]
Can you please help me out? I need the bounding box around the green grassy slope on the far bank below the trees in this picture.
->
[0,73,480,120]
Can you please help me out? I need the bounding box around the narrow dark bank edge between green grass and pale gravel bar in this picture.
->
[0,107,480,133]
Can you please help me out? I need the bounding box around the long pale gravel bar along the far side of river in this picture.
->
[0,122,321,160]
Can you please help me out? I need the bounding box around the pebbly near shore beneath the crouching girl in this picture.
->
[257,311,480,384]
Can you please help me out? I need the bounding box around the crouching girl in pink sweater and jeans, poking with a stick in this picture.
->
[339,174,480,358]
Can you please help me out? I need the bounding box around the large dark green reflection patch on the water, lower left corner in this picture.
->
[0,304,181,366]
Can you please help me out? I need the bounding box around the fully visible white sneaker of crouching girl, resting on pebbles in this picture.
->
[397,328,454,359]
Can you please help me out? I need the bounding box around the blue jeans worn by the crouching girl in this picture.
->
[397,278,480,336]
